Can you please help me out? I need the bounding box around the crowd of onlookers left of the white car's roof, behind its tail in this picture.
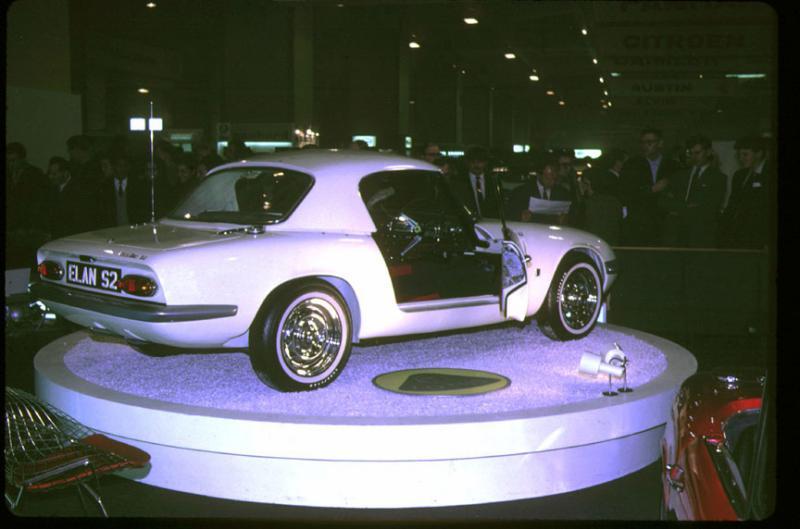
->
[6,135,230,269]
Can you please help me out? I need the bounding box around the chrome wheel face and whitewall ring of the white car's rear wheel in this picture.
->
[276,292,346,382]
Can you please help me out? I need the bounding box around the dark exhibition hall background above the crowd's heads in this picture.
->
[7,0,779,164]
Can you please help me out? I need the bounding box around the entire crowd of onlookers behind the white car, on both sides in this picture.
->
[6,129,772,268]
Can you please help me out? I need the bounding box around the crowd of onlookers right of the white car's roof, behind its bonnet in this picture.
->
[412,128,772,249]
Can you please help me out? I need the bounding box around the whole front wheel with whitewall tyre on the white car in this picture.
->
[539,254,603,340]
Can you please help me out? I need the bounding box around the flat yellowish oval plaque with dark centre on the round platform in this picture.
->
[372,367,511,395]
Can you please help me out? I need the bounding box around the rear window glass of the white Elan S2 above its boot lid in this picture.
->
[167,167,313,224]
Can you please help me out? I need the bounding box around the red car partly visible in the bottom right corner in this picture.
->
[661,369,774,520]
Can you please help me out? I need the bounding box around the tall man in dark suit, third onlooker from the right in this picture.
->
[622,128,679,246]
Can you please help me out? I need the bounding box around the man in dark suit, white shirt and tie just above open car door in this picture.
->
[448,147,500,218]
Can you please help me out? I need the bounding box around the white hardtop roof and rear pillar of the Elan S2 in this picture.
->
[209,149,440,234]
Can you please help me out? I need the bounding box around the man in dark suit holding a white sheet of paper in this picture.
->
[506,158,571,224]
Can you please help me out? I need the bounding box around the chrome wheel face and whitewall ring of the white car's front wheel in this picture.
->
[558,263,601,333]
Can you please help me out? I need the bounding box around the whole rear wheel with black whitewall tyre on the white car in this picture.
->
[250,281,352,391]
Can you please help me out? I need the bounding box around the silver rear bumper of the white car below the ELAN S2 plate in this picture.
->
[28,281,239,323]
